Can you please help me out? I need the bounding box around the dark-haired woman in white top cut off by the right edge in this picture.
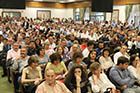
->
[128,54,140,80]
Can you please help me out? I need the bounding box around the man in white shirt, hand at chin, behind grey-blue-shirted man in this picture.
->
[114,45,130,64]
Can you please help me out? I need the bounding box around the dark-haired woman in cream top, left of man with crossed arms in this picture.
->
[99,48,114,71]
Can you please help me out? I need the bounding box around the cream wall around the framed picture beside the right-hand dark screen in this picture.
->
[106,5,126,22]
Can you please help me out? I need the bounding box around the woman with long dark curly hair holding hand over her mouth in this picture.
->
[64,65,91,93]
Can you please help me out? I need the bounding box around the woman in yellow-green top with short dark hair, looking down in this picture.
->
[46,53,68,80]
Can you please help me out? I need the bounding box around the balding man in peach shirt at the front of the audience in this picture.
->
[36,69,71,93]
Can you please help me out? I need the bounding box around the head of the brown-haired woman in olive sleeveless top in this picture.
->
[28,55,39,68]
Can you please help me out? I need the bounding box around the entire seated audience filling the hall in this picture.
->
[0,16,140,93]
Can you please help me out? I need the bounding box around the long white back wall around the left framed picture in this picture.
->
[0,7,73,18]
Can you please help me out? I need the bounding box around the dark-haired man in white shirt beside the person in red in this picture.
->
[82,40,94,58]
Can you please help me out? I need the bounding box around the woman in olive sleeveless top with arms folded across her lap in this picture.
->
[21,55,42,93]
